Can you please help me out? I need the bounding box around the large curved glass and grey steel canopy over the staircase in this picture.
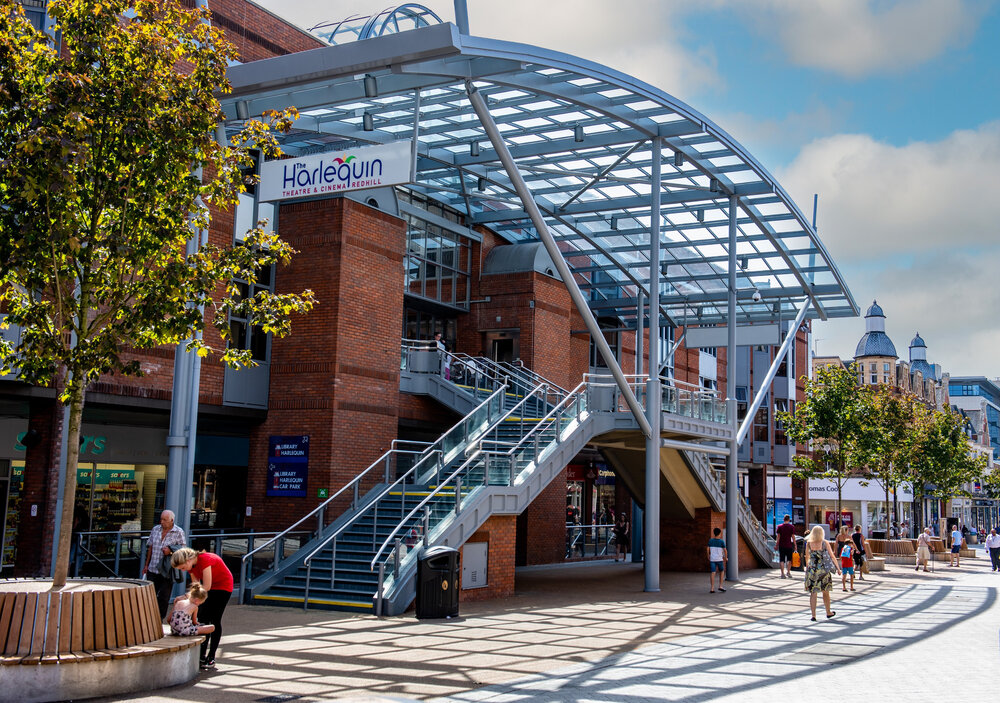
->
[223,18,858,326]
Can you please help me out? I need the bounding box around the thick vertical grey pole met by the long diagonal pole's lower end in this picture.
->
[643,138,663,593]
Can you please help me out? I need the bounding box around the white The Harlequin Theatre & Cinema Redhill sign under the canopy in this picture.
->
[257,140,412,202]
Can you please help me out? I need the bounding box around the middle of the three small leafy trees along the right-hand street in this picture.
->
[856,386,917,532]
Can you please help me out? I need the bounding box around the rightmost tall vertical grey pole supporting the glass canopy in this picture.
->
[726,195,740,581]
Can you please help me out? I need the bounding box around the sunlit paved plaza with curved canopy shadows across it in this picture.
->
[95,548,1000,703]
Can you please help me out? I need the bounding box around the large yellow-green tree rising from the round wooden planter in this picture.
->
[0,0,313,587]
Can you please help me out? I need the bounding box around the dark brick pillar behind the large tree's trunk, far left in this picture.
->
[14,398,63,577]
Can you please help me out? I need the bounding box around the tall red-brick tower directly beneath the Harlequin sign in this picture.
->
[247,198,405,529]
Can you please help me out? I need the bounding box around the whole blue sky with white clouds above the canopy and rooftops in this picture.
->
[257,0,1000,378]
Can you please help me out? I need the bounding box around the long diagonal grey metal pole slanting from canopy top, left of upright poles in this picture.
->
[466,81,653,437]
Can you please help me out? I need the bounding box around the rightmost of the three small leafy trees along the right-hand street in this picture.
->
[908,406,986,532]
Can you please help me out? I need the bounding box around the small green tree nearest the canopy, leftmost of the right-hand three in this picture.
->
[775,364,867,532]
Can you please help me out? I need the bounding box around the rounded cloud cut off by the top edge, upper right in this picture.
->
[726,0,988,78]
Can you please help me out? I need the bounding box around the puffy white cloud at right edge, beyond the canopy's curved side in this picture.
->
[777,122,1000,262]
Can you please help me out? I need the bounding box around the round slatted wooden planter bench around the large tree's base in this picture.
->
[0,579,203,702]
